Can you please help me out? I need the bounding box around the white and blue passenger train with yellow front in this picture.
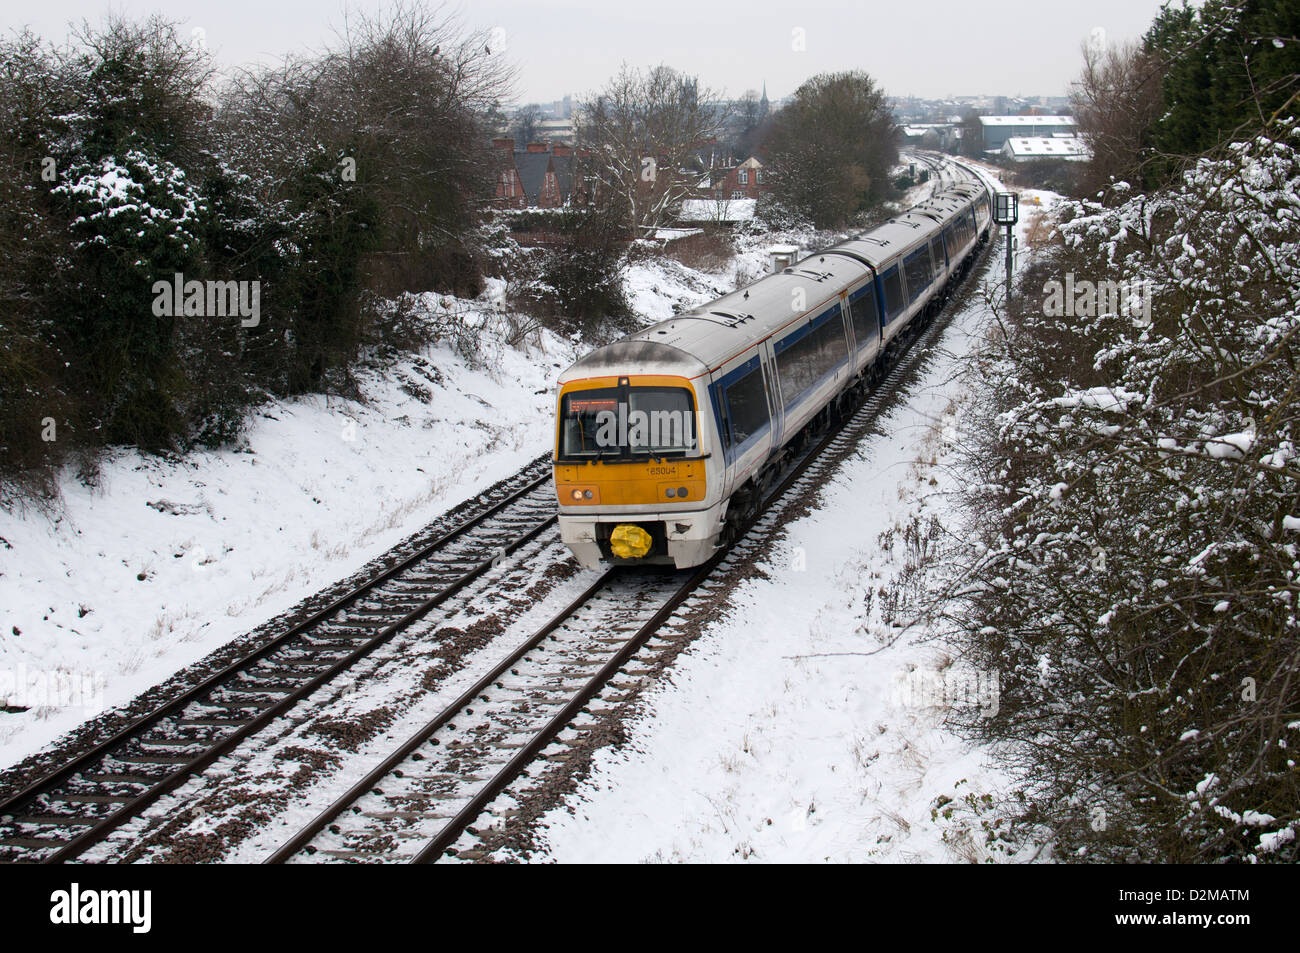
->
[553,164,992,569]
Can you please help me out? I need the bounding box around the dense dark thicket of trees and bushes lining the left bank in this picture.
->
[0,3,508,503]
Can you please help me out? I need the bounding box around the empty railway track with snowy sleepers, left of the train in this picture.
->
[0,458,555,863]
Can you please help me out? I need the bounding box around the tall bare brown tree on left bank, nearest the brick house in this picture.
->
[224,3,514,256]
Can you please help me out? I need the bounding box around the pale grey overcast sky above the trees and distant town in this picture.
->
[5,0,1161,103]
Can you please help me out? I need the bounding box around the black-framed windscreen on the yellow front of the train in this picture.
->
[560,387,697,460]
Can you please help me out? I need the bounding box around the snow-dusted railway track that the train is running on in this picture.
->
[268,204,980,863]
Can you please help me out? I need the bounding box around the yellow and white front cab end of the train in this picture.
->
[554,376,725,569]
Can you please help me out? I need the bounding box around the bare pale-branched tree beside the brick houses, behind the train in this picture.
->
[579,65,729,228]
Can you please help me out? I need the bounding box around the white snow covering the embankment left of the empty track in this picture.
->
[0,261,712,767]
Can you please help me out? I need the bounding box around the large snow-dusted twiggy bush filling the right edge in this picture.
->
[956,122,1300,862]
